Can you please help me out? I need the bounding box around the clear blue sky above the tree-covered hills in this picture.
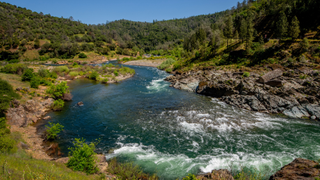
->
[4,0,242,24]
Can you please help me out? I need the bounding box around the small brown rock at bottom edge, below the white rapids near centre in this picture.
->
[197,169,234,180]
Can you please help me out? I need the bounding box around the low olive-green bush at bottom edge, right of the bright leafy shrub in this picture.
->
[107,158,158,180]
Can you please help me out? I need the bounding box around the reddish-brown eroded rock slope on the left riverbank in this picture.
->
[6,98,54,127]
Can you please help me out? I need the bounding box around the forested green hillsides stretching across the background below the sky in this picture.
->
[0,0,320,64]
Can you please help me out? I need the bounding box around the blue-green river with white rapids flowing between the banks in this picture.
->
[39,62,320,179]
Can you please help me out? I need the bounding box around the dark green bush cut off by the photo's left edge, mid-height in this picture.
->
[0,79,20,117]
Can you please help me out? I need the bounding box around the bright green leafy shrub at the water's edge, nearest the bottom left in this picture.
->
[67,138,98,174]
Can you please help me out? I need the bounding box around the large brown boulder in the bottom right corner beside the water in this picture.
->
[270,158,320,180]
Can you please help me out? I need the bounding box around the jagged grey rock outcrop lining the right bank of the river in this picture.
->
[166,65,320,120]
